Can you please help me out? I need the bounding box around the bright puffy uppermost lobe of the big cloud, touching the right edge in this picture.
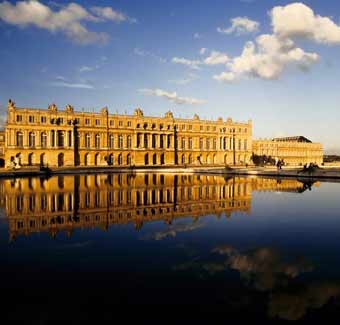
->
[270,3,340,44]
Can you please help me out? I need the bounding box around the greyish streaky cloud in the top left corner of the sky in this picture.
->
[0,0,134,45]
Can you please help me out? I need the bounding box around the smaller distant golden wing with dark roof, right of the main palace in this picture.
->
[253,136,323,165]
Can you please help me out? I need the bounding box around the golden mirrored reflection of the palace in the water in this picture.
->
[0,174,318,241]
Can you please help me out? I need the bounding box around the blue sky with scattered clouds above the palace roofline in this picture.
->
[0,0,340,153]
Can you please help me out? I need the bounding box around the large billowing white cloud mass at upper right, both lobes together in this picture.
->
[213,3,334,82]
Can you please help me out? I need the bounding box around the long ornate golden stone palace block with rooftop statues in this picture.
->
[5,100,252,167]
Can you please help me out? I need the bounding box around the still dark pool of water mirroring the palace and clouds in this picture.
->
[0,174,340,324]
